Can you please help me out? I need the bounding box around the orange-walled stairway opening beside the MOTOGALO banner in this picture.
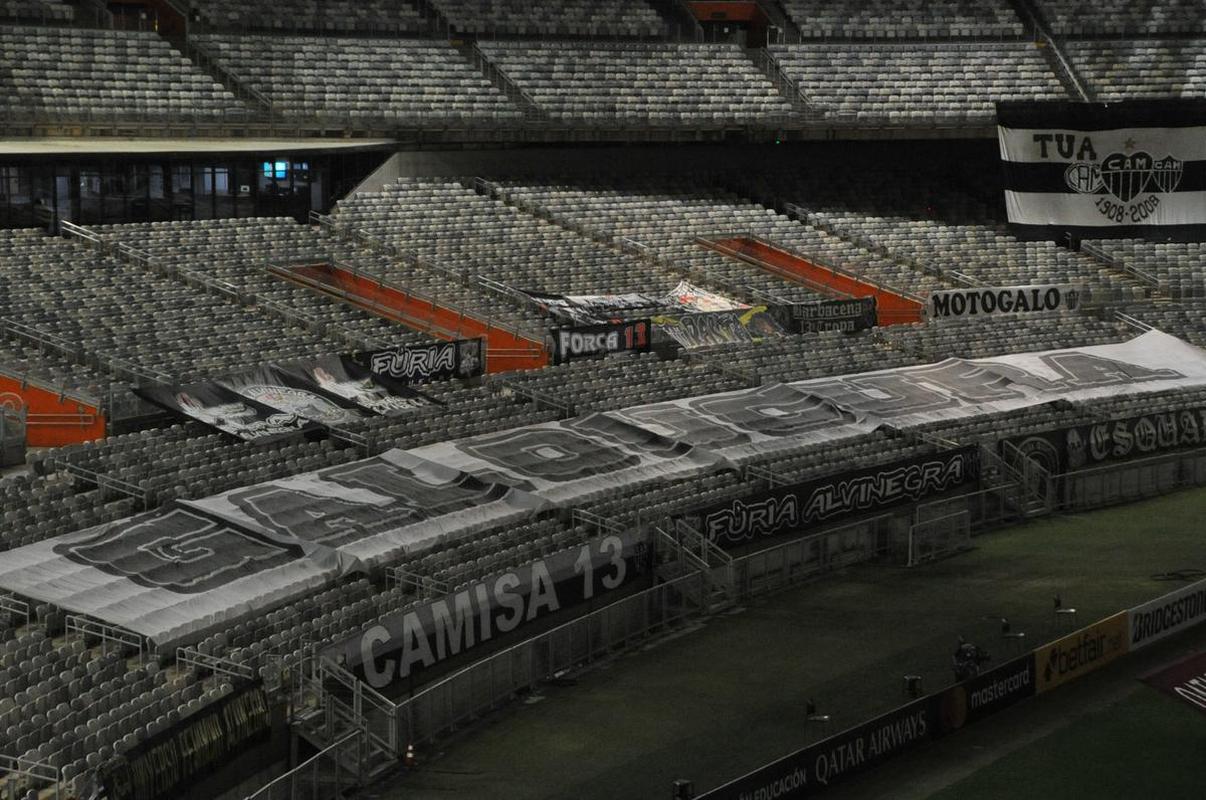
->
[696,237,925,325]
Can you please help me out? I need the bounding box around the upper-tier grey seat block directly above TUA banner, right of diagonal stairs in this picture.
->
[1064,39,1206,103]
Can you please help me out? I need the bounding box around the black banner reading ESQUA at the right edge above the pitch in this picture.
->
[1002,407,1206,474]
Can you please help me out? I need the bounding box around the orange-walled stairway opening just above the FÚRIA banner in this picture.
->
[269,264,549,373]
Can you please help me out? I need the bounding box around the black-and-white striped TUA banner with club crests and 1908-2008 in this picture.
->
[996,100,1206,239]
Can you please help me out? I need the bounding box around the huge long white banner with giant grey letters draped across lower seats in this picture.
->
[0,332,1206,644]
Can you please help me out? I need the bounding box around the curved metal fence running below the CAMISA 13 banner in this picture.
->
[397,574,706,744]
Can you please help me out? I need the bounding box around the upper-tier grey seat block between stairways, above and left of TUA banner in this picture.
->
[771,42,1069,124]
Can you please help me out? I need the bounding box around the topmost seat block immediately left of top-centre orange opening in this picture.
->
[432,0,666,36]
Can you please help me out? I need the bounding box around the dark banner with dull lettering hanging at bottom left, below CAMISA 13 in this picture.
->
[100,685,271,800]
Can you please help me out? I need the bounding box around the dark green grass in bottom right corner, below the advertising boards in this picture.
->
[930,685,1206,800]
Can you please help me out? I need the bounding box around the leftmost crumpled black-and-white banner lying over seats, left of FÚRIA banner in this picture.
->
[134,381,324,442]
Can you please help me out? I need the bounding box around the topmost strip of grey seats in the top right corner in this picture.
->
[1036,0,1206,36]
